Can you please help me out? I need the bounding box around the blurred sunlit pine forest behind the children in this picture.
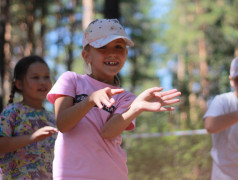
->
[0,0,238,180]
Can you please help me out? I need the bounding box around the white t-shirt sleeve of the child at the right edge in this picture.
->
[203,95,226,119]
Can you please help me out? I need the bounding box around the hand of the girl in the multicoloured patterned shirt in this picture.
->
[30,126,58,142]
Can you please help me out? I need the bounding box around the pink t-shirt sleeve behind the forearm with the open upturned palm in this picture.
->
[114,92,136,131]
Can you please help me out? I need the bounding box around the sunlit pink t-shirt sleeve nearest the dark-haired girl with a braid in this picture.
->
[47,71,78,104]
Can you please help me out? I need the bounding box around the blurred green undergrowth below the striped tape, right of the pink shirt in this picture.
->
[125,135,211,180]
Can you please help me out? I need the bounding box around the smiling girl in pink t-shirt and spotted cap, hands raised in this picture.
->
[47,19,181,180]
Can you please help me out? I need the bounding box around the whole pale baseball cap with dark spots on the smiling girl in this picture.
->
[82,19,134,48]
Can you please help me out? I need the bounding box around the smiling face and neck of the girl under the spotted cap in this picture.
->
[82,39,128,85]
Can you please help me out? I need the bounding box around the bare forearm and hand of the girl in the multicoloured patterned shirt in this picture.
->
[0,126,58,153]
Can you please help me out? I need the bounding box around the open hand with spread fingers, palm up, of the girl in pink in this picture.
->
[131,87,181,112]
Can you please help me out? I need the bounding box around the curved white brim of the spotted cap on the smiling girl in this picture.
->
[89,35,134,48]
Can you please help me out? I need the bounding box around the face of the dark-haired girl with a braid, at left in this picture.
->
[16,62,52,109]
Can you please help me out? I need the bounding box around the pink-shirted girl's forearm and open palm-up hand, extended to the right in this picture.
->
[101,87,181,139]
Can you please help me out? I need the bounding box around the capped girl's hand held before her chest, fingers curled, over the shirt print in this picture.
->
[89,87,124,109]
